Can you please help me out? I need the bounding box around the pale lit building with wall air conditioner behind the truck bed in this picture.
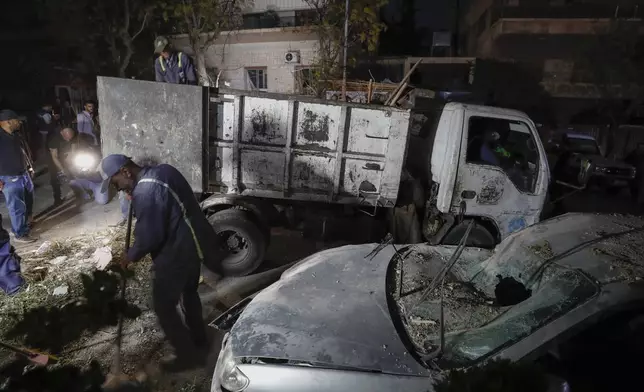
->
[173,0,318,93]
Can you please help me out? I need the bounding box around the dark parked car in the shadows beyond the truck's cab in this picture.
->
[554,133,636,193]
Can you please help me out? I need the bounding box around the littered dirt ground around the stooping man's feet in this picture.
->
[0,176,329,392]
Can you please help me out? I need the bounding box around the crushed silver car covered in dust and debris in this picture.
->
[211,214,644,392]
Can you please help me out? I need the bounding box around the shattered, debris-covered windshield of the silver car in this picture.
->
[394,250,598,368]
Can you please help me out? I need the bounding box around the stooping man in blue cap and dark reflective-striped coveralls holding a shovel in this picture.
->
[99,155,220,371]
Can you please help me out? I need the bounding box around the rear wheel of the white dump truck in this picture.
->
[208,209,266,276]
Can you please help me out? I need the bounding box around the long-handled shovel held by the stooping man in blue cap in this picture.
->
[102,202,140,391]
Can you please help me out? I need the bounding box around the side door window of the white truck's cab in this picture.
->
[466,116,539,193]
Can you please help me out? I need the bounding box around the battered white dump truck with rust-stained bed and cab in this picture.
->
[97,77,549,275]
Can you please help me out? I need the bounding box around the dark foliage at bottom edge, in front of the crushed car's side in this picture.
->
[434,360,548,392]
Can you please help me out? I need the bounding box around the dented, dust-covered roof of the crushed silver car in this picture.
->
[489,213,644,284]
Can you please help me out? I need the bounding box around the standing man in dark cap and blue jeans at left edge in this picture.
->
[0,110,37,243]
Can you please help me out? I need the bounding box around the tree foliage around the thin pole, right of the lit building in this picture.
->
[304,0,389,95]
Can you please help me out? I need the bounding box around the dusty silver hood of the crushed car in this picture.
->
[229,244,429,376]
